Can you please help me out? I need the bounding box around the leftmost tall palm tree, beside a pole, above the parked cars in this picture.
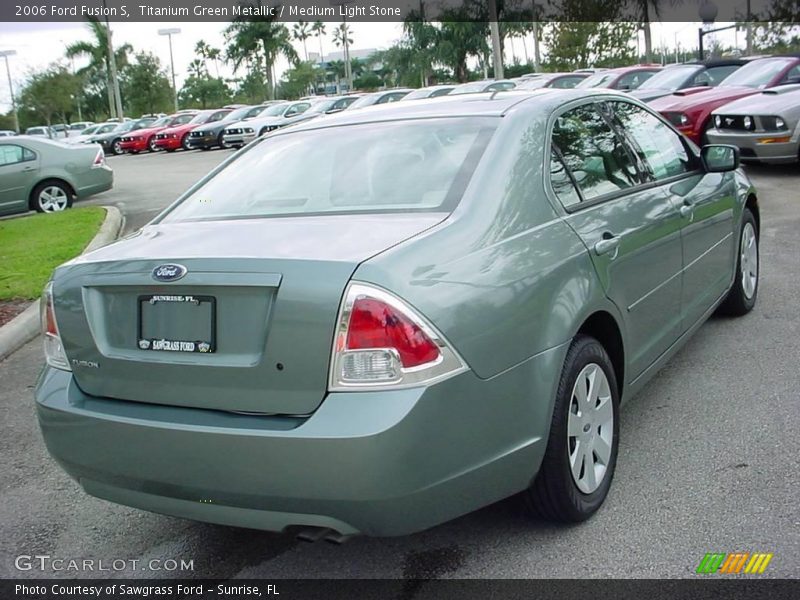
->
[66,18,133,116]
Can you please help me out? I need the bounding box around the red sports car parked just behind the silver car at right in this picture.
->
[650,56,800,145]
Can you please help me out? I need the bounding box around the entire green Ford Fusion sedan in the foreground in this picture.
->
[36,89,759,536]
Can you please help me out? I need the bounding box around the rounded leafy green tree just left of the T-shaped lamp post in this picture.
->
[122,52,173,115]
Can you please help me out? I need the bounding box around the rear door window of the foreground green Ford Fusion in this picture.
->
[553,104,640,201]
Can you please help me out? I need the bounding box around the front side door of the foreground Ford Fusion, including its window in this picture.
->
[610,101,736,332]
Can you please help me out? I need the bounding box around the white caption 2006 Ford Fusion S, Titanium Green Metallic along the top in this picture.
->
[15,4,400,19]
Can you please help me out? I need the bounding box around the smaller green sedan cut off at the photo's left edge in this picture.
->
[0,136,114,215]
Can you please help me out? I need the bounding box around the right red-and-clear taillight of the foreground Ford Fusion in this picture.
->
[329,283,466,390]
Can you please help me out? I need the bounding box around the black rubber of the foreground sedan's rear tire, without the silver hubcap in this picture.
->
[524,334,619,523]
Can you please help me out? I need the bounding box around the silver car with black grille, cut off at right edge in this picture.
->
[706,84,800,164]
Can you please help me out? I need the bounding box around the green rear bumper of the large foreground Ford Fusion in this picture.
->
[36,346,566,535]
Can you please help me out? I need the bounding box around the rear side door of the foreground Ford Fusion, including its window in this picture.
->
[550,102,682,378]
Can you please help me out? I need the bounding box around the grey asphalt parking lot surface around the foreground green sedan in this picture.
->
[0,150,800,578]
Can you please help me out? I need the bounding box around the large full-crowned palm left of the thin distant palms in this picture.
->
[225,0,299,100]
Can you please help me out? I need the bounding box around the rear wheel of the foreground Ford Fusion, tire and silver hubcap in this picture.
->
[524,334,619,523]
